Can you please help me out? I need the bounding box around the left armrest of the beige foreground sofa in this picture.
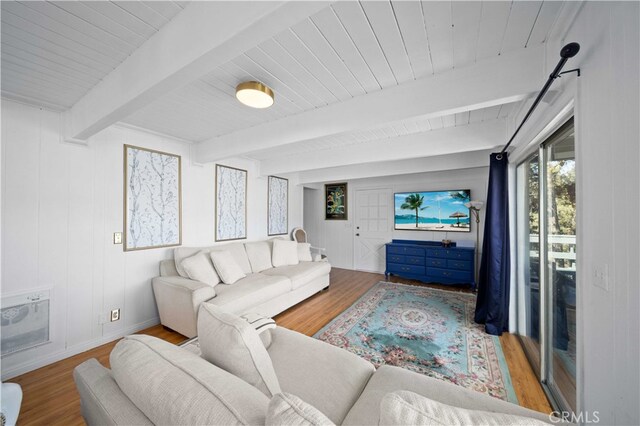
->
[73,358,153,425]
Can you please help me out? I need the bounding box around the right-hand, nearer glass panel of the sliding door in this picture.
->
[544,120,577,411]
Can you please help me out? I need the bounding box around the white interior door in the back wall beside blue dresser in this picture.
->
[353,188,393,273]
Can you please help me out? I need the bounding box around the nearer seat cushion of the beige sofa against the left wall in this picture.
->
[207,272,291,314]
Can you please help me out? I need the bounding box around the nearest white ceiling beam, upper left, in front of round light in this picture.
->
[64,1,330,140]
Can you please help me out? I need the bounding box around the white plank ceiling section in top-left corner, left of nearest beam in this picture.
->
[2,1,187,109]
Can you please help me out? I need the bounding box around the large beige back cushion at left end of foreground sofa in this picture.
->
[110,335,269,425]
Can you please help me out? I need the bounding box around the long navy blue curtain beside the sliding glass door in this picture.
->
[475,153,510,336]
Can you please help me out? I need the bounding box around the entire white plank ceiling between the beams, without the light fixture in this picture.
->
[1,1,565,171]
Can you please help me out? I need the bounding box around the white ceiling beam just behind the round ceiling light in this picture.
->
[196,46,545,163]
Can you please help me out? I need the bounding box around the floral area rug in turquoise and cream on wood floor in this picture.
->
[313,282,518,404]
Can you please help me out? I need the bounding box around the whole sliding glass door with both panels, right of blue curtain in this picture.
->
[517,119,578,412]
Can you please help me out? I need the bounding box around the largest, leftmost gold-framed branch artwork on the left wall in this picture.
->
[123,145,182,251]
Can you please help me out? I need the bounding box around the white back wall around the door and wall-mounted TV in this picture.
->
[305,166,489,272]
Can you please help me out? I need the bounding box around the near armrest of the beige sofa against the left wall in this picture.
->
[152,276,216,337]
